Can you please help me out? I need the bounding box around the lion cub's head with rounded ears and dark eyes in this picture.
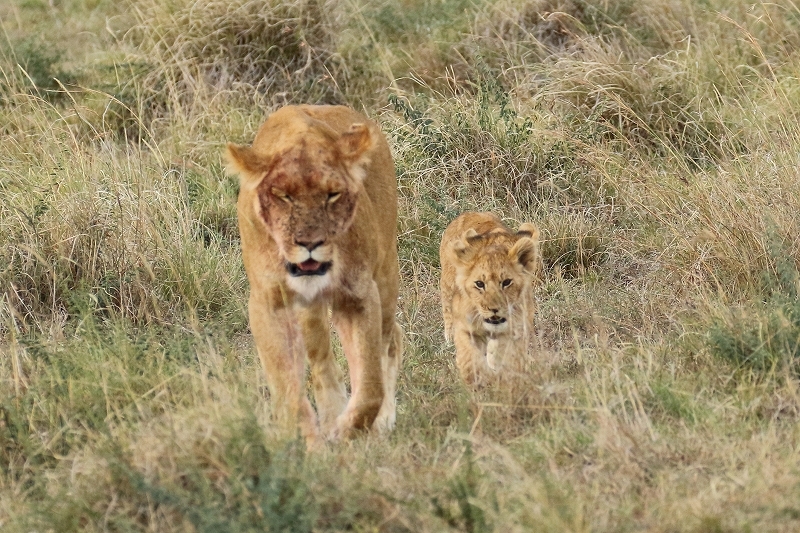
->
[453,223,541,334]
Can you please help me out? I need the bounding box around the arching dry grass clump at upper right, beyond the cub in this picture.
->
[544,43,737,166]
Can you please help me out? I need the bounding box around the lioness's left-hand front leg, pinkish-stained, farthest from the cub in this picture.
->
[249,296,319,445]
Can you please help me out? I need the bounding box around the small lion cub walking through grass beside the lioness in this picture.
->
[439,213,541,385]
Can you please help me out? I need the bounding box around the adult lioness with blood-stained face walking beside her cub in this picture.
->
[227,105,402,444]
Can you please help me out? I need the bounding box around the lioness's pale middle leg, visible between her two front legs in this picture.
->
[298,302,347,435]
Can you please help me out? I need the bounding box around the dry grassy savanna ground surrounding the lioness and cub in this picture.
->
[0,0,800,533]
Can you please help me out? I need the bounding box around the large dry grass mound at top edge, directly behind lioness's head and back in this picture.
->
[128,0,344,109]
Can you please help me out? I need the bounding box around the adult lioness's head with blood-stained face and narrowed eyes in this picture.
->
[227,108,373,300]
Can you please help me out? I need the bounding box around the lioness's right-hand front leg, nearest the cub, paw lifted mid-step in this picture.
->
[333,284,389,437]
